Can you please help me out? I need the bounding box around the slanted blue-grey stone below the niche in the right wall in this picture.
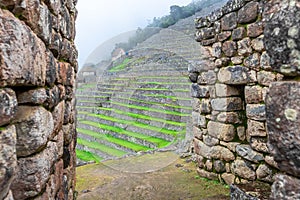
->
[236,145,264,163]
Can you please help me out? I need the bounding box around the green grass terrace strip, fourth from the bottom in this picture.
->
[79,120,171,148]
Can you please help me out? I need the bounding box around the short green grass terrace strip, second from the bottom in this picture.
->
[77,138,127,157]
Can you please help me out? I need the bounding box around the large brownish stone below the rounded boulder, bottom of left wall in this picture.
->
[11,142,58,200]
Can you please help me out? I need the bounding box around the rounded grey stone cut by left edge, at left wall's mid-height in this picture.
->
[0,88,17,126]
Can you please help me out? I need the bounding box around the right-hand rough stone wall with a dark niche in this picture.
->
[189,0,300,199]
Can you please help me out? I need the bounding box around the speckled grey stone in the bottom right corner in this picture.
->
[270,174,300,200]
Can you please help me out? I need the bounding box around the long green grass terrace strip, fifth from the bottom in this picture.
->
[79,113,182,136]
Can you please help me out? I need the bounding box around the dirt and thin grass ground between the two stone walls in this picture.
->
[77,152,229,200]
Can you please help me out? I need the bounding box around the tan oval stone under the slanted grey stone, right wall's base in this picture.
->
[231,159,256,181]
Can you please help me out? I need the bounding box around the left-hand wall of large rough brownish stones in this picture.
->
[0,0,77,200]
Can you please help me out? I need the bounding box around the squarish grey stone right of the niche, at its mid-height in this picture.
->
[246,104,266,121]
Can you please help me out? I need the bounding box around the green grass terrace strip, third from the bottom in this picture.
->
[76,128,151,152]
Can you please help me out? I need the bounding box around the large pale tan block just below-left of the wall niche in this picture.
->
[207,121,236,142]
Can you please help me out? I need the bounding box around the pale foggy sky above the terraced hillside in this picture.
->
[75,0,192,67]
